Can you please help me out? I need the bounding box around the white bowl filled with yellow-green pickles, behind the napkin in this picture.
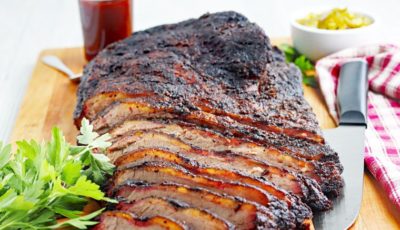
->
[291,8,379,61]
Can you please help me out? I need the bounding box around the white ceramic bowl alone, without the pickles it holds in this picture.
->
[291,10,377,61]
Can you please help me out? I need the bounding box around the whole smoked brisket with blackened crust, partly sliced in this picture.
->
[79,12,343,229]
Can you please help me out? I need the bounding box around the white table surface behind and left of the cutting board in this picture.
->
[0,0,400,141]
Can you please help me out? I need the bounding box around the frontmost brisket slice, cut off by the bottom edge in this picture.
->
[93,211,186,230]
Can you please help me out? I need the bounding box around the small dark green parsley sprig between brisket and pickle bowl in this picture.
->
[279,44,318,88]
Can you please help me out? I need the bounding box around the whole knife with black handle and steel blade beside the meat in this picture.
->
[313,60,368,230]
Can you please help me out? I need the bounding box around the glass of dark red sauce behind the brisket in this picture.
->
[79,0,132,61]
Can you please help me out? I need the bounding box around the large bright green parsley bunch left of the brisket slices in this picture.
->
[0,119,115,230]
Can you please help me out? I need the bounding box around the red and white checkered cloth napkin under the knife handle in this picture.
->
[316,44,400,209]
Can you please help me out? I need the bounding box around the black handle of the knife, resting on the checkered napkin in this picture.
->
[337,60,368,126]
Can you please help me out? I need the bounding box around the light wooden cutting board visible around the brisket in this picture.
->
[10,39,400,230]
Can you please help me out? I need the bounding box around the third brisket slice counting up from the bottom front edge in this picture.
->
[115,183,294,229]
